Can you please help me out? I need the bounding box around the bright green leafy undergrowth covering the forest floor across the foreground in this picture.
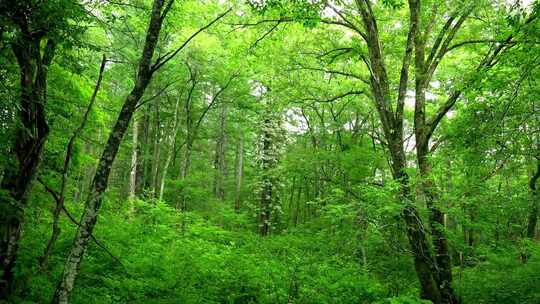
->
[11,201,540,304]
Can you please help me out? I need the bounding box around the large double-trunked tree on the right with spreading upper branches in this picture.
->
[247,0,536,303]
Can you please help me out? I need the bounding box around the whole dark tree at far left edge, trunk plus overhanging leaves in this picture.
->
[0,1,84,298]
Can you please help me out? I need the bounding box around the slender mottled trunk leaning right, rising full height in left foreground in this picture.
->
[52,0,172,304]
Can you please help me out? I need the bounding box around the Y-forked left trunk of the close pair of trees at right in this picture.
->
[357,0,444,304]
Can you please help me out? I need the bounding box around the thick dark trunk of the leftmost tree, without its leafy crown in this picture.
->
[0,32,56,299]
